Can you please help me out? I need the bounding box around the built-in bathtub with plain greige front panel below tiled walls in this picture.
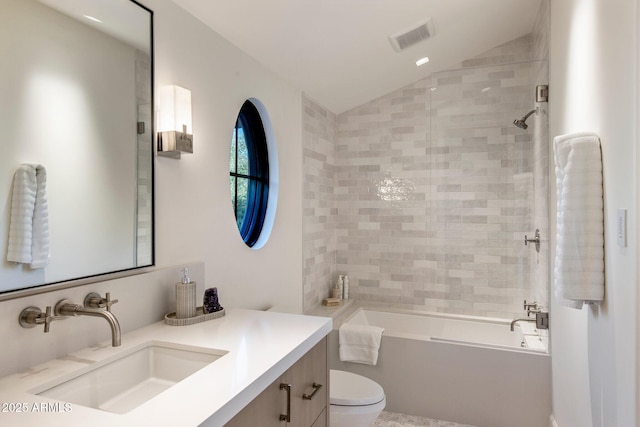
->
[329,308,551,427]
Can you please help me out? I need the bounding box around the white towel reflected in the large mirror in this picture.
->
[7,164,49,269]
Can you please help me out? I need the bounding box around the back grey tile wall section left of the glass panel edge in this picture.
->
[336,79,430,307]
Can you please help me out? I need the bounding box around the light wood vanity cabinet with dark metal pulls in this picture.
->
[226,337,329,427]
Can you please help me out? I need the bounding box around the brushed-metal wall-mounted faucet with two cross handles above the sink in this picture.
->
[18,292,121,347]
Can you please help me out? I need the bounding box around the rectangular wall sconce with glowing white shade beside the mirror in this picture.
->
[157,85,193,159]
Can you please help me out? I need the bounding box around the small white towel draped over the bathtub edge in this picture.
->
[339,323,384,365]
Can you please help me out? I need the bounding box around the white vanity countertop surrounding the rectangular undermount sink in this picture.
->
[0,309,332,427]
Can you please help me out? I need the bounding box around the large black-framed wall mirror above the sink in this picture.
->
[0,0,154,299]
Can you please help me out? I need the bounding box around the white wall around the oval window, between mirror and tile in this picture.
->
[146,0,302,311]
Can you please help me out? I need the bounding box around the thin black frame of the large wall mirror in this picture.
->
[0,0,156,302]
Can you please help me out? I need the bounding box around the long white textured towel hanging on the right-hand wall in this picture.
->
[553,133,604,308]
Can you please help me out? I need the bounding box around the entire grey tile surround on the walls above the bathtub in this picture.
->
[304,30,548,318]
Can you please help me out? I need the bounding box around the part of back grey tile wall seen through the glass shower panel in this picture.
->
[424,54,533,317]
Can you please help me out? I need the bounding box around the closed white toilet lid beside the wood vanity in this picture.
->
[329,369,384,406]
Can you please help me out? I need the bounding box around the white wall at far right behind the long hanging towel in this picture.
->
[550,0,638,427]
